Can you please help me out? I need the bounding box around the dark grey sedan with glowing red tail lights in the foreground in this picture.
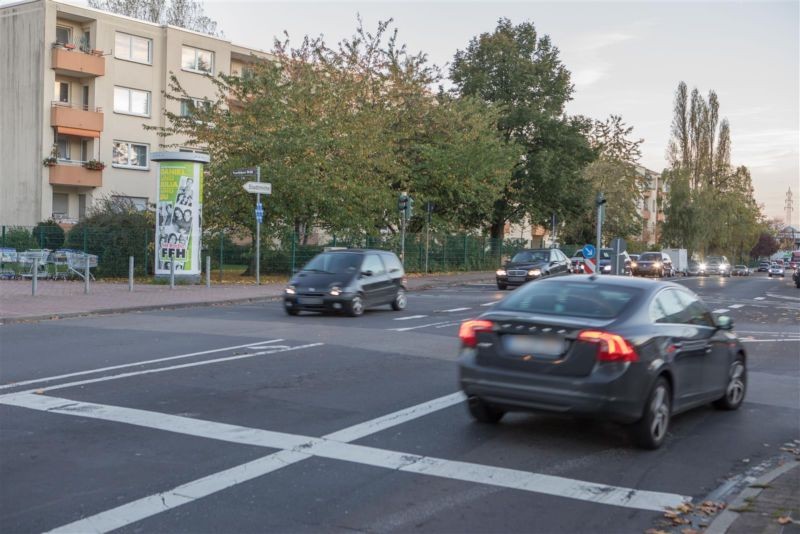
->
[458,276,747,449]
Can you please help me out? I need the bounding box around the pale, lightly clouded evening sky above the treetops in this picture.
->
[20,0,800,226]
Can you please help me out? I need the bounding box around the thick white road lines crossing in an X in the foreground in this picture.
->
[0,393,691,532]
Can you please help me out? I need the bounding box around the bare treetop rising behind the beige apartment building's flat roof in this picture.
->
[89,0,222,37]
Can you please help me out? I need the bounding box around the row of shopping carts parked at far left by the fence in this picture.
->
[0,248,97,280]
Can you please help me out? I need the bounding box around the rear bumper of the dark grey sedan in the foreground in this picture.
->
[458,349,650,423]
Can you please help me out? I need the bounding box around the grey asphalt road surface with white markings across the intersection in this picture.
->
[0,275,800,533]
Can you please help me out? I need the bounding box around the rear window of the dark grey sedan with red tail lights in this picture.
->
[495,280,641,319]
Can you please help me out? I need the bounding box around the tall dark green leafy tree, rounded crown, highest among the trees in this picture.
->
[450,19,594,238]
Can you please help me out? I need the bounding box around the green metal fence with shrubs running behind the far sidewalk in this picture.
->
[0,225,556,281]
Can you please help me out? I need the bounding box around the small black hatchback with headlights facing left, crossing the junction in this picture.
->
[283,249,406,317]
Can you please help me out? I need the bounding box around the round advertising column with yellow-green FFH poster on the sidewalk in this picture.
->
[151,152,209,282]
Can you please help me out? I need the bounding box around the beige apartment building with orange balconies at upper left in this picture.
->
[0,0,268,225]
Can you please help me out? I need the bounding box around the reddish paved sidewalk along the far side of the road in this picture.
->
[0,272,494,324]
